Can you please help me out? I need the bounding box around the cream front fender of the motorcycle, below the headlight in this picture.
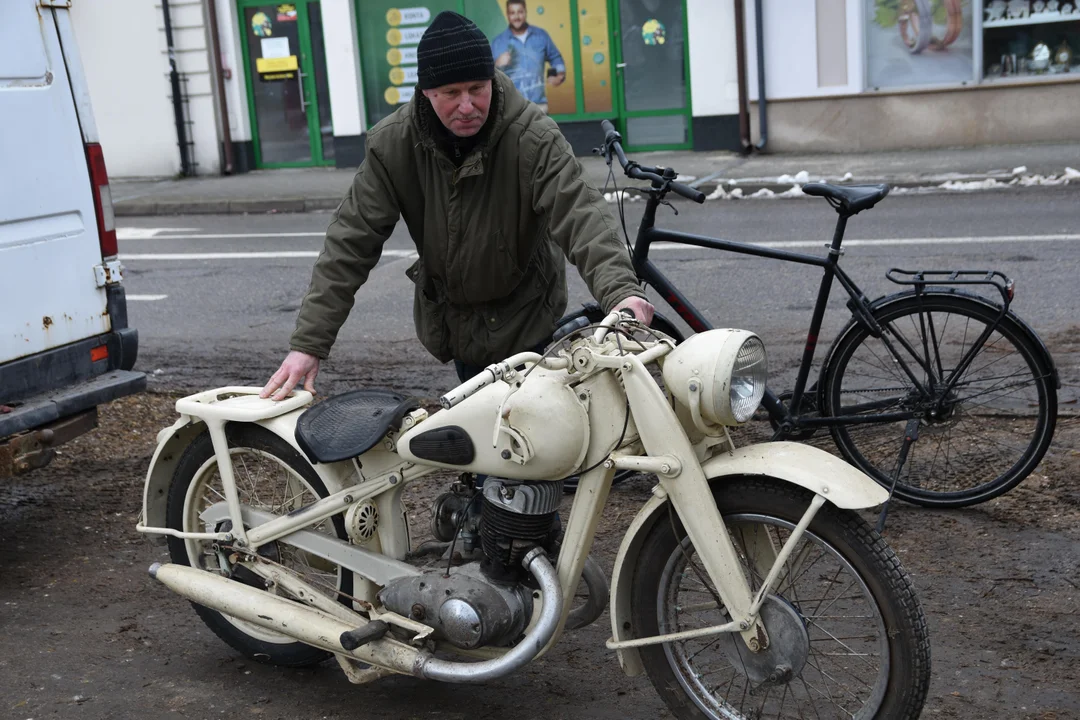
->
[610,443,889,676]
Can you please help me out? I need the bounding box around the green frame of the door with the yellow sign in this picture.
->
[237,0,334,169]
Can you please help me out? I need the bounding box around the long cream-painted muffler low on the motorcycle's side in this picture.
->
[150,562,423,675]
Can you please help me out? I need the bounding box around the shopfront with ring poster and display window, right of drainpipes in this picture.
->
[746,0,1080,151]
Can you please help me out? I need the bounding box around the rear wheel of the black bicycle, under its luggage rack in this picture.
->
[823,291,1057,507]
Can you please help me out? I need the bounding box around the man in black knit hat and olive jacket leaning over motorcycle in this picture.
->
[261,12,653,399]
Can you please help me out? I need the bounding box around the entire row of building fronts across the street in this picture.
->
[72,0,1080,177]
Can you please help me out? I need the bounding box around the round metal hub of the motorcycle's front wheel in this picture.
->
[719,595,810,687]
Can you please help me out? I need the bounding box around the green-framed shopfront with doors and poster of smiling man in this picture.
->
[227,0,738,167]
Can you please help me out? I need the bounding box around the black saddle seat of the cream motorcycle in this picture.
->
[296,390,420,462]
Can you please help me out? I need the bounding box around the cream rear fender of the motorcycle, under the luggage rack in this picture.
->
[143,407,358,539]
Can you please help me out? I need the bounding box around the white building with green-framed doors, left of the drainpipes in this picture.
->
[72,0,739,177]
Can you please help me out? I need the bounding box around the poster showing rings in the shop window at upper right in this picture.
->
[866,0,974,89]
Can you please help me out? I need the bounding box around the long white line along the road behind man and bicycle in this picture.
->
[113,233,1080,261]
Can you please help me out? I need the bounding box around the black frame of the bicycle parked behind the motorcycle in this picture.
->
[631,184,1011,435]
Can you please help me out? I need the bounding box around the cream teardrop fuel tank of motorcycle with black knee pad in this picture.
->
[397,368,590,480]
